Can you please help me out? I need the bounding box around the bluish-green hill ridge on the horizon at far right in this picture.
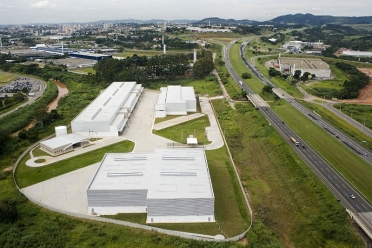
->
[264,14,372,26]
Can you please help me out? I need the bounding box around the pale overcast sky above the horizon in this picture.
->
[0,0,372,25]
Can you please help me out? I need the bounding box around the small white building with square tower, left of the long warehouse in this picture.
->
[40,126,89,156]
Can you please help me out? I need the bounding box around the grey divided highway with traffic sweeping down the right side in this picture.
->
[224,41,372,236]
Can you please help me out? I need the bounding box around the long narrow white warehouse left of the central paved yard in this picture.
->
[71,82,143,137]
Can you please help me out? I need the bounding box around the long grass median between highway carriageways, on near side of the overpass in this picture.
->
[272,100,372,202]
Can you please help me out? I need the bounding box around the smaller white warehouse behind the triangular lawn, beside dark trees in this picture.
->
[155,85,196,118]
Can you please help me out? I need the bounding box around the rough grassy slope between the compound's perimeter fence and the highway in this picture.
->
[213,100,363,247]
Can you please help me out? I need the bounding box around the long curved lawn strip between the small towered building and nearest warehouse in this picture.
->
[15,140,134,188]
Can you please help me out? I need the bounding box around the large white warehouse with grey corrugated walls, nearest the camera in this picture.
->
[87,148,215,223]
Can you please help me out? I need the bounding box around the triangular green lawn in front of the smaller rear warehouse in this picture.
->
[153,116,210,144]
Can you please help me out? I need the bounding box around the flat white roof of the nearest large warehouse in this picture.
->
[88,148,214,199]
